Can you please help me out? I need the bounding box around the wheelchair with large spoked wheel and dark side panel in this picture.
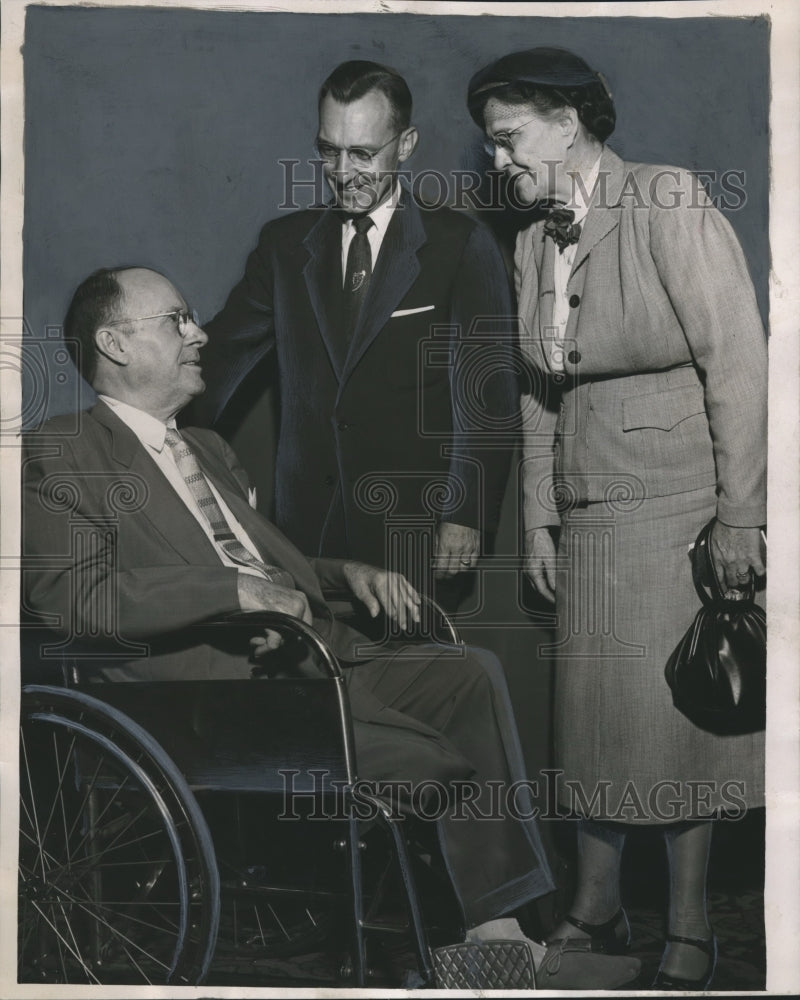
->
[18,601,460,987]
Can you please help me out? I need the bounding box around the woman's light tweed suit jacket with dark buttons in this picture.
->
[515,149,767,528]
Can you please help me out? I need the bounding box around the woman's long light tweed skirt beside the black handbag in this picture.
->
[542,489,764,823]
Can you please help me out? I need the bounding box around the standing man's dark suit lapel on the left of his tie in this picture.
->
[303,208,344,380]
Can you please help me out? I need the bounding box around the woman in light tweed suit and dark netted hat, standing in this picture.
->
[469,49,767,989]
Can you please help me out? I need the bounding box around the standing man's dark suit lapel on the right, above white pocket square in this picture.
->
[342,191,427,381]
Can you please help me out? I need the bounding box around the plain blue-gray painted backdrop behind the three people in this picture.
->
[18,7,769,844]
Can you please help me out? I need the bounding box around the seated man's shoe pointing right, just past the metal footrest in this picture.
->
[536,938,641,992]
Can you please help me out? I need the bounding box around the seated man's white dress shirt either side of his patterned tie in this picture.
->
[100,395,262,576]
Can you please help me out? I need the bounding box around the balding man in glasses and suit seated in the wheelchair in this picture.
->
[23,268,639,989]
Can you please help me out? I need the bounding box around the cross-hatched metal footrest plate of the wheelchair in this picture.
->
[432,941,536,990]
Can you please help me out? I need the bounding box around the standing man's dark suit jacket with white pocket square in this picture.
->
[196,192,519,565]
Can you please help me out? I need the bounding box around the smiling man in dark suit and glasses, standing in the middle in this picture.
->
[197,61,518,589]
